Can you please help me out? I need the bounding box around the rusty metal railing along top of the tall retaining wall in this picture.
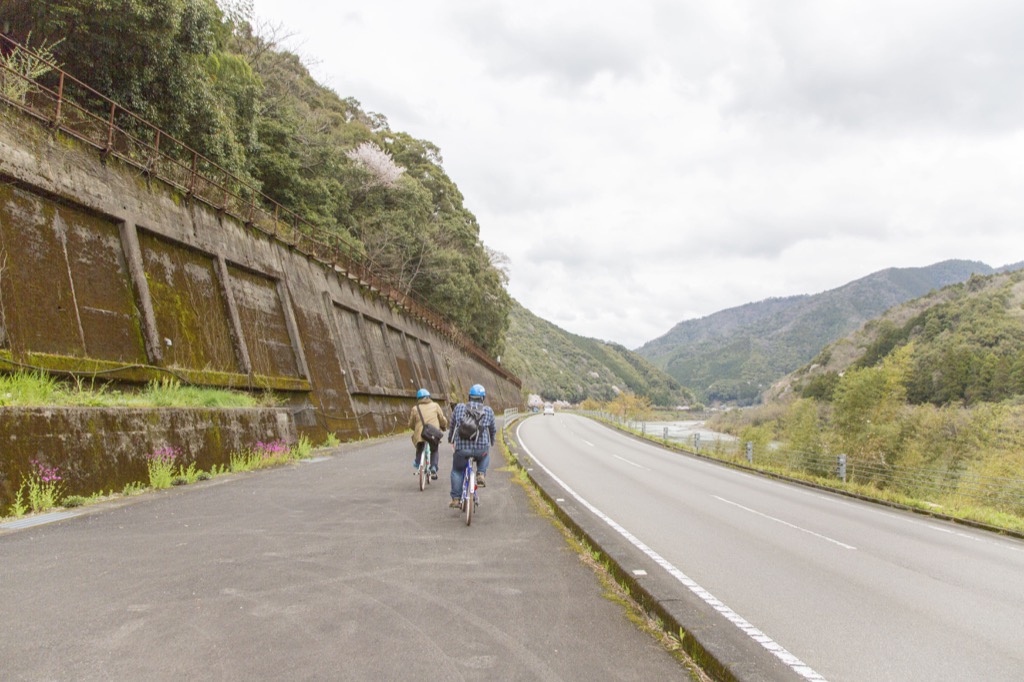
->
[0,33,522,387]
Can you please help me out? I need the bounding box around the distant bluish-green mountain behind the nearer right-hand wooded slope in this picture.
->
[637,260,994,404]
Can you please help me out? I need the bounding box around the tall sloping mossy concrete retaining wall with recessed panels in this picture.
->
[0,103,521,503]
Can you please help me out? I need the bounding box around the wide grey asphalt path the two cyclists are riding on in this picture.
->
[0,436,689,682]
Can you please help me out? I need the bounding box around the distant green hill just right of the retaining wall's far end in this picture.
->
[504,300,693,407]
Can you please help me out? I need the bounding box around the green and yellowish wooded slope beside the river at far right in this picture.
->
[711,270,1024,512]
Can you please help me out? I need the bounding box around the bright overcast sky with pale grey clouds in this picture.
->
[247,0,1024,348]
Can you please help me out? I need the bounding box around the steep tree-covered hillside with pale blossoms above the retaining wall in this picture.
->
[0,0,511,355]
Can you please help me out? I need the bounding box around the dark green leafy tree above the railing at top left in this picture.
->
[8,0,258,177]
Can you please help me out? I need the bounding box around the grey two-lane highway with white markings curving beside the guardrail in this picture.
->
[518,414,1024,682]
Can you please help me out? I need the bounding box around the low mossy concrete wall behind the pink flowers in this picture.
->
[0,408,296,499]
